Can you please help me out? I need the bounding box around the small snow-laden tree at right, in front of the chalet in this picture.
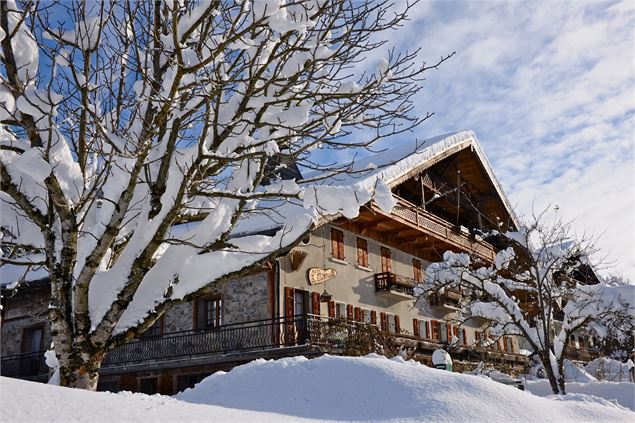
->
[419,212,634,394]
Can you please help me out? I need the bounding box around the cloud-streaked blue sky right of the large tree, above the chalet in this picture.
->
[370,0,635,280]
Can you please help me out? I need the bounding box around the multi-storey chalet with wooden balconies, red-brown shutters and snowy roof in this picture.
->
[1,131,527,394]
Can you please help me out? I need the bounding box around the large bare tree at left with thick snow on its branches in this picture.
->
[0,0,447,389]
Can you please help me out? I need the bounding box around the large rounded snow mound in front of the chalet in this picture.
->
[177,355,635,422]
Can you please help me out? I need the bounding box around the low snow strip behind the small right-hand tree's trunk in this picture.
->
[526,379,635,412]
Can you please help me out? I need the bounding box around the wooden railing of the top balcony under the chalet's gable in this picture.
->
[392,197,495,260]
